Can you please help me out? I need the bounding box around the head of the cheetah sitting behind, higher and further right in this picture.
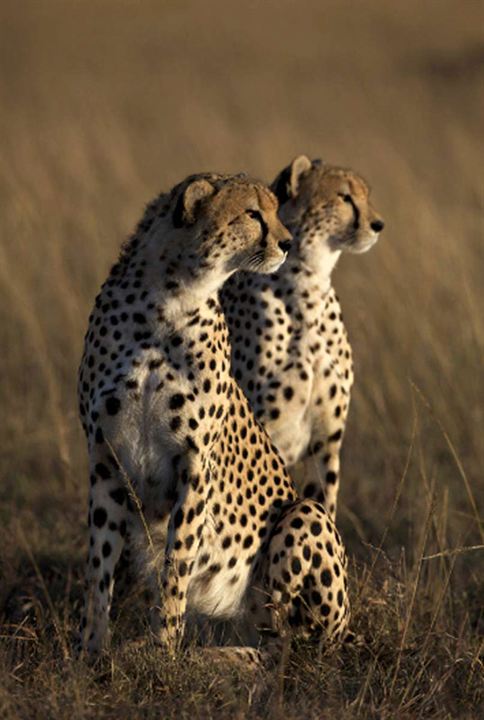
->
[271,155,384,253]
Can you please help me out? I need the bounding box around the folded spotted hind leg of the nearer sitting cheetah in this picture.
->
[249,499,350,644]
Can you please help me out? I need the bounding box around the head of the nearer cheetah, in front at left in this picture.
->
[172,173,291,278]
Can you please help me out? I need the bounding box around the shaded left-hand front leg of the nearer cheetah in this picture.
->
[79,453,128,657]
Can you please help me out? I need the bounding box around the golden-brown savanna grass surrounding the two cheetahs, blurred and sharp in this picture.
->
[0,0,484,720]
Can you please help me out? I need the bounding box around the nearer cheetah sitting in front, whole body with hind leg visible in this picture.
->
[79,174,349,655]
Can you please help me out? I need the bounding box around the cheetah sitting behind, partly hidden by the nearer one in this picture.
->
[221,155,383,518]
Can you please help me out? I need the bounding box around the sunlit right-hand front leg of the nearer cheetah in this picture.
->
[149,469,208,653]
